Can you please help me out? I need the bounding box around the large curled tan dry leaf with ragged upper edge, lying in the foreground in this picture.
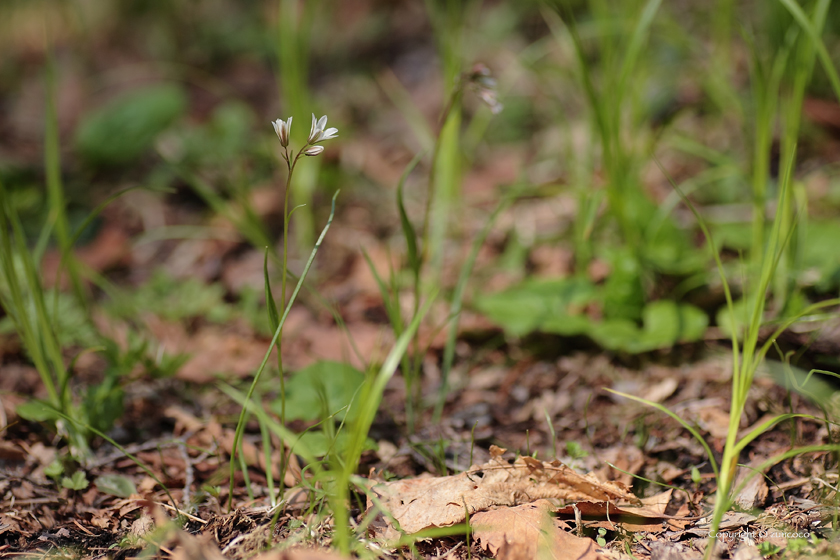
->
[368,446,638,538]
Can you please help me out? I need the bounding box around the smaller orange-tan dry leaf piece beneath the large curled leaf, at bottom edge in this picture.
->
[470,500,603,560]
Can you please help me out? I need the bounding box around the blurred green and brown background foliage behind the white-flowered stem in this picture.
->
[0,0,840,394]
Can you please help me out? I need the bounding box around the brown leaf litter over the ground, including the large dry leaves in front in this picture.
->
[0,2,840,560]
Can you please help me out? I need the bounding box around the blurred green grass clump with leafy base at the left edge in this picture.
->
[0,57,151,462]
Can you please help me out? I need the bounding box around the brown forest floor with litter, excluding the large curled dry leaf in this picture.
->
[0,2,840,560]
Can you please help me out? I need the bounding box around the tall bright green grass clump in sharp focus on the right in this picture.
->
[576,0,840,558]
